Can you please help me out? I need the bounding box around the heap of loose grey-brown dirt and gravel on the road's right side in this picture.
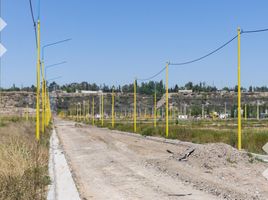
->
[164,142,268,199]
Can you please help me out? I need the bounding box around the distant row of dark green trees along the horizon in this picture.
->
[2,80,268,95]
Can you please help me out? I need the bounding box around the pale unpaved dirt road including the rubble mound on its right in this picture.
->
[55,119,268,200]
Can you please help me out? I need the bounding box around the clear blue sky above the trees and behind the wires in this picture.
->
[2,0,268,87]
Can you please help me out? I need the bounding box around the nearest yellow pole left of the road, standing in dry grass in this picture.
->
[36,19,40,141]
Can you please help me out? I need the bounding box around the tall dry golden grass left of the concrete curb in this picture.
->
[0,120,49,200]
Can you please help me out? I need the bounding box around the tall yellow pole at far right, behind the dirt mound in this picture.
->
[237,28,242,150]
